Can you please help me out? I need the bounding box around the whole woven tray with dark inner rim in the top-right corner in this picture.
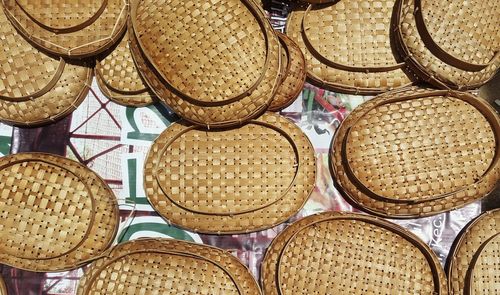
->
[393,0,500,90]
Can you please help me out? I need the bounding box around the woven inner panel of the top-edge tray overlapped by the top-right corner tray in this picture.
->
[302,0,397,68]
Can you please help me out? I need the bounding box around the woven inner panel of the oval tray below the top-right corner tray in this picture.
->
[346,96,496,201]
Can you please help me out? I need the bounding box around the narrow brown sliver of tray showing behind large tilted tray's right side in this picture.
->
[268,32,306,111]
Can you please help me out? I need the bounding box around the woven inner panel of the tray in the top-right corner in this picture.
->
[421,0,500,64]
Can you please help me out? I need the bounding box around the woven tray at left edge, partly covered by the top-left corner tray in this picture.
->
[0,4,92,126]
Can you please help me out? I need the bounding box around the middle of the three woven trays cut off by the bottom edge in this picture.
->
[261,212,448,295]
